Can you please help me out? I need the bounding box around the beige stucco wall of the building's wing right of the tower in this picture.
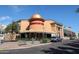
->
[44,20,64,38]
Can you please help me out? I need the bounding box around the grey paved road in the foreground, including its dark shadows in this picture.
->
[0,40,79,54]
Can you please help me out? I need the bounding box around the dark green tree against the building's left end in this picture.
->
[5,22,18,32]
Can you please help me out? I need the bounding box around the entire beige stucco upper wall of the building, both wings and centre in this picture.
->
[19,20,64,37]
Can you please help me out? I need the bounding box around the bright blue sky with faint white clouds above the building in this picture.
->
[0,5,79,32]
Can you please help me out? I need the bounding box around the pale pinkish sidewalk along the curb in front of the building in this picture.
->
[0,42,51,51]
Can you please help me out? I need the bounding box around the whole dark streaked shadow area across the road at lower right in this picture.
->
[42,41,79,54]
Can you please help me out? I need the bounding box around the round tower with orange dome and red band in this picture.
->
[29,14,44,31]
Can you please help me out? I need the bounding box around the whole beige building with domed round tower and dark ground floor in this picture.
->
[18,14,64,40]
